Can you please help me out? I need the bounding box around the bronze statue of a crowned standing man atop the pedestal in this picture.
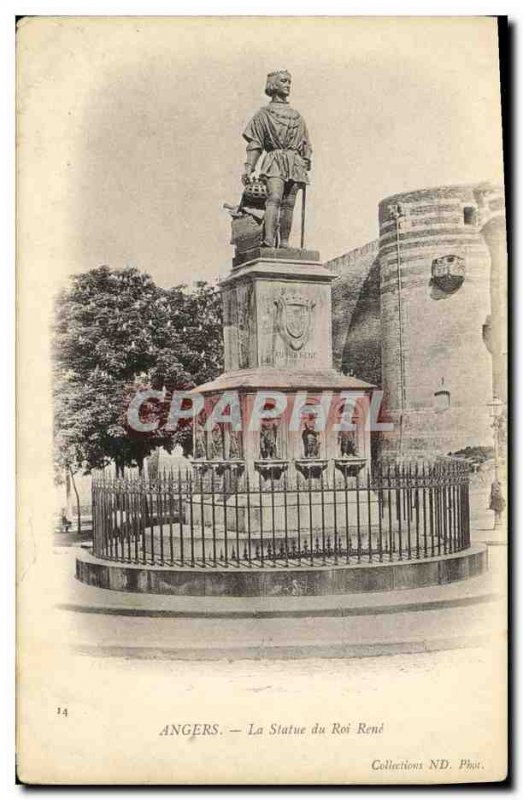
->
[242,70,312,247]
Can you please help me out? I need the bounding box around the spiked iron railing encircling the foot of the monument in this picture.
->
[92,461,470,569]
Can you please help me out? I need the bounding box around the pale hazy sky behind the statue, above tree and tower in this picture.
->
[17,17,503,286]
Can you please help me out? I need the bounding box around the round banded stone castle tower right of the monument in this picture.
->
[379,184,504,453]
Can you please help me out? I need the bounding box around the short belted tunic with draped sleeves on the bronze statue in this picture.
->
[243,103,312,183]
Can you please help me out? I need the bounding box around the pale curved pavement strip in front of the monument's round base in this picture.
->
[62,603,503,660]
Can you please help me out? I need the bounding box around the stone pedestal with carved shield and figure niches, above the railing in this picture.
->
[195,249,373,492]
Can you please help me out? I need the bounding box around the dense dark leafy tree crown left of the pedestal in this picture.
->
[54,266,223,471]
